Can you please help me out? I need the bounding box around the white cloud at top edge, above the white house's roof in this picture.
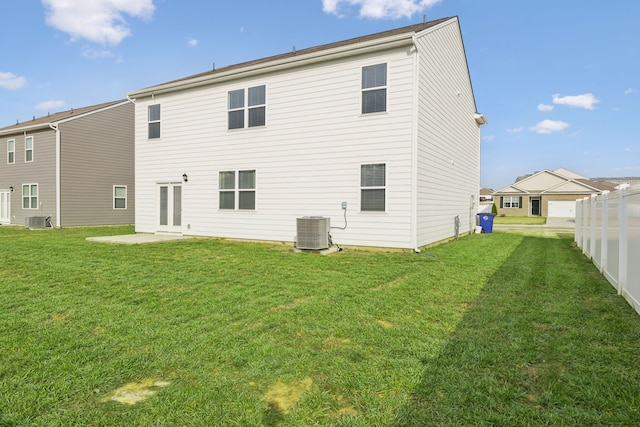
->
[322,0,441,19]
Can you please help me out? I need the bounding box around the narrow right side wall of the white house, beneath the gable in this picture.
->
[416,20,480,246]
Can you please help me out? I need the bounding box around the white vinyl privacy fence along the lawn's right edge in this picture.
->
[575,185,640,314]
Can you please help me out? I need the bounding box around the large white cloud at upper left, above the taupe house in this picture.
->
[42,0,154,45]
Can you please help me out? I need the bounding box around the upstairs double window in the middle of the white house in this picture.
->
[227,85,267,129]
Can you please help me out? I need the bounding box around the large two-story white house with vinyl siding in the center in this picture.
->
[129,17,486,249]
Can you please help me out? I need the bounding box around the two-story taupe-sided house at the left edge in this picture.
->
[0,100,135,227]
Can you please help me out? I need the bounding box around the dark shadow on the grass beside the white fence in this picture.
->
[397,233,640,426]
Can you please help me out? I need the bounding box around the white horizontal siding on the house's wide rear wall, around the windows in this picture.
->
[135,43,415,248]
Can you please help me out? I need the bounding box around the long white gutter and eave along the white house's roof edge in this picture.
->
[127,31,414,99]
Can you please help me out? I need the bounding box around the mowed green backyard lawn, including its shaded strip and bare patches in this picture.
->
[0,227,640,426]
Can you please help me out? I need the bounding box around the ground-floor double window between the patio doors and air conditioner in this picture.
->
[219,170,256,210]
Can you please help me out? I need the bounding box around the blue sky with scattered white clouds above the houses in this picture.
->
[0,0,640,190]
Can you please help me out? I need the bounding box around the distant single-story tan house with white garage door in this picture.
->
[493,169,616,218]
